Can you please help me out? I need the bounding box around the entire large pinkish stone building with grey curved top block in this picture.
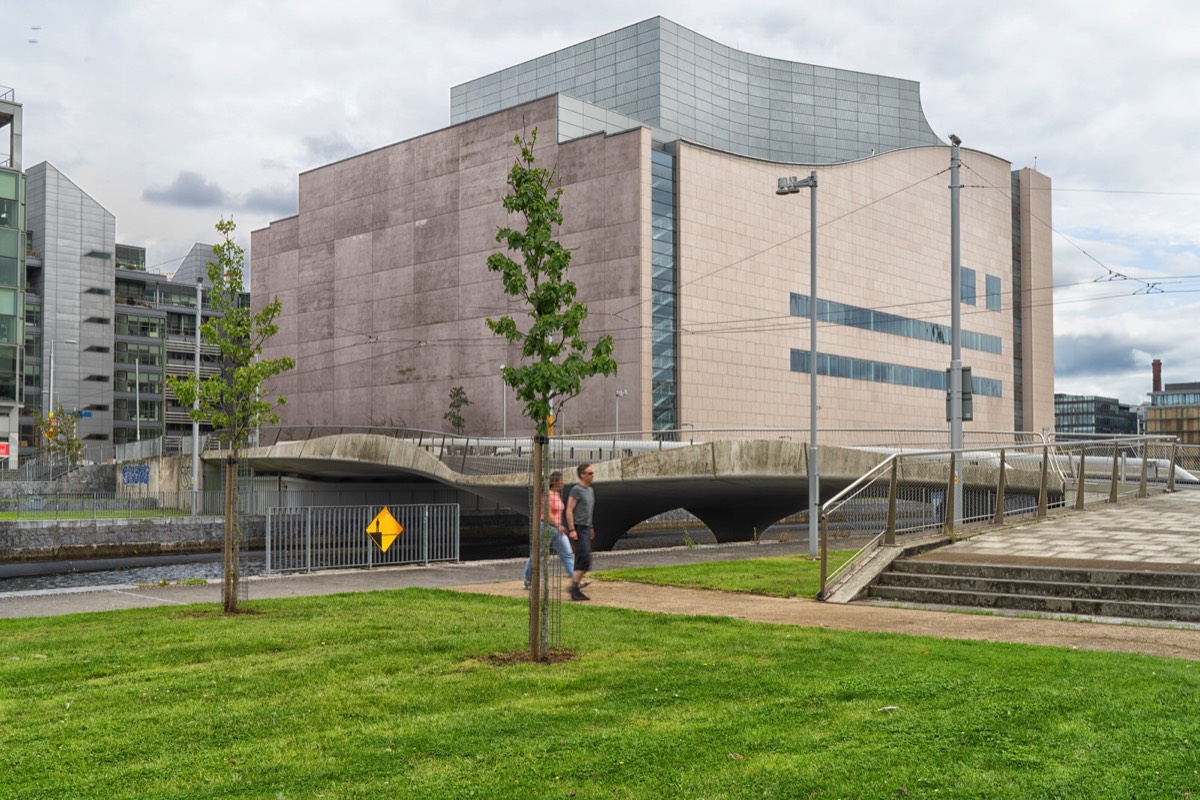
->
[252,17,1054,435]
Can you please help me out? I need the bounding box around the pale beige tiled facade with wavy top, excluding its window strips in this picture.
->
[679,145,1013,431]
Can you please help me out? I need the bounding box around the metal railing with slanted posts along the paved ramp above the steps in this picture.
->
[818,437,1185,599]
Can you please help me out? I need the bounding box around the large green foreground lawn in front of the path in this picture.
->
[0,589,1200,799]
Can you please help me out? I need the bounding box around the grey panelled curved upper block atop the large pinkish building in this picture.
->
[450,17,944,164]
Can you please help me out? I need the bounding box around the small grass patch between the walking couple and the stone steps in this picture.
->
[593,551,858,597]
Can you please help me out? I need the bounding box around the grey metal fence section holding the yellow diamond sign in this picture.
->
[264,505,460,575]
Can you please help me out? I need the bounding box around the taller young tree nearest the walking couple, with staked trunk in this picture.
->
[486,128,617,661]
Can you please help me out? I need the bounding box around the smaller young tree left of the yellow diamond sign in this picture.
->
[167,219,295,613]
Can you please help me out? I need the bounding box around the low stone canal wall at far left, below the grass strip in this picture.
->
[0,517,265,561]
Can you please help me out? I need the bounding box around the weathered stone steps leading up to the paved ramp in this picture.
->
[865,557,1200,624]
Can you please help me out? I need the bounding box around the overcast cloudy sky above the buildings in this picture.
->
[0,0,1200,403]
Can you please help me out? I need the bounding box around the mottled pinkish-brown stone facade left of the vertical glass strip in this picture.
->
[252,97,649,435]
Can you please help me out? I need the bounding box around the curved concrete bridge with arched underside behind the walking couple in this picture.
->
[234,433,884,549]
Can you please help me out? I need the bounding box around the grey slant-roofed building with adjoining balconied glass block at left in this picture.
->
[20,162,217,458]
